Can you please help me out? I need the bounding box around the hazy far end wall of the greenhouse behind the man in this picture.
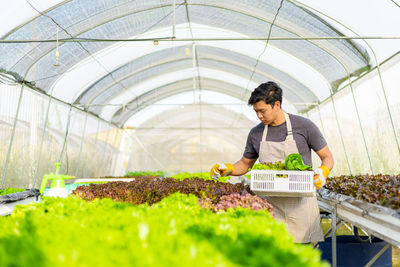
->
[128,128,250,174]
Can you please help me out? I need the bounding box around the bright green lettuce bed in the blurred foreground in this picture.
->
[0,193,329,267]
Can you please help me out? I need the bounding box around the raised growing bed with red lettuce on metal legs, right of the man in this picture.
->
[317,174,400,266]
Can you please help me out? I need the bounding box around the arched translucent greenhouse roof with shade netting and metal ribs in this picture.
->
[0,0,400,126]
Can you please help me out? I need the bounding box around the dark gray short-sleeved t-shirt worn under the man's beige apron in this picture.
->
[243,114,326,168]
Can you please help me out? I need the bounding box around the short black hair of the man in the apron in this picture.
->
[248,82,282,107]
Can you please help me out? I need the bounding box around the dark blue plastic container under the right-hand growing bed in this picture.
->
[319,235,392,267]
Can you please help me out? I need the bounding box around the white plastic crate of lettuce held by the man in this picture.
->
[250,170,315,197]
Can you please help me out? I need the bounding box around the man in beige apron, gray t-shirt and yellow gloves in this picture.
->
[210,82,334,243]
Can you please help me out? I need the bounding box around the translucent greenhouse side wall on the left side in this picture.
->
[0,84,121,188]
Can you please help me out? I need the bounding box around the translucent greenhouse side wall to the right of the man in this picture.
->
[309,55,400,175]
